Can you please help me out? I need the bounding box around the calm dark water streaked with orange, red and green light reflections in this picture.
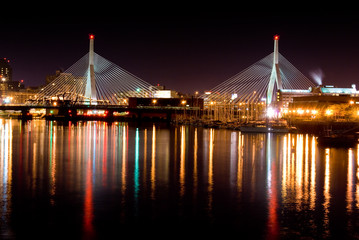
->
[0,119,359,239]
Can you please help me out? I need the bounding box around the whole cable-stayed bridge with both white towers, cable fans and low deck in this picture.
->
[0,35,315,120]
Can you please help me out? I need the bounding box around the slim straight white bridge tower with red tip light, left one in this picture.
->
[85,34,97,104]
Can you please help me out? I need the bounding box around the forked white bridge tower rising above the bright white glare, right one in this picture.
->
[267,35,283,105]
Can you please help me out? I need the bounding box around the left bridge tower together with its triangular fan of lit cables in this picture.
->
[35,35,155,105]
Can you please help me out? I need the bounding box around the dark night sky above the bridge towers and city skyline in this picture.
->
[0,9,359,93]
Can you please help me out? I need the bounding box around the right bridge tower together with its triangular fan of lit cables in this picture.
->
[201,35,315,105]
